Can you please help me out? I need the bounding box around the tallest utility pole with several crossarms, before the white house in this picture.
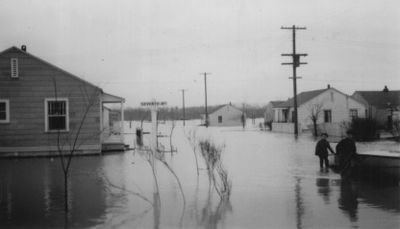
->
[281,25,307,137]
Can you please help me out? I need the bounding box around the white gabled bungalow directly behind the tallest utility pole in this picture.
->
[272,85,365,136]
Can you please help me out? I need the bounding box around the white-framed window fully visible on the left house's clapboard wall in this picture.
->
[45,98,69,131]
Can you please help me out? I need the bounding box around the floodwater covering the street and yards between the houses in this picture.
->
[0,123,400,228]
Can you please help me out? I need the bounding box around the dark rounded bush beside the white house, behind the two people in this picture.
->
[349,118,379,141]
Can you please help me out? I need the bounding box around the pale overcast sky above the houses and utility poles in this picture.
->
[0,0,400,106]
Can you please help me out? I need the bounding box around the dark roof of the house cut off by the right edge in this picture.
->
[353,90,400,109]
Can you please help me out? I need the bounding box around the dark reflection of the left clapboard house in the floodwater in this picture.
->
[0,158,105,227]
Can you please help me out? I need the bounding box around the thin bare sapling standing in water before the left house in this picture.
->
[52,78,102,213]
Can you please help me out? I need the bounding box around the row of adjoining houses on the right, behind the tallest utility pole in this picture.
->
[264,85,400,136]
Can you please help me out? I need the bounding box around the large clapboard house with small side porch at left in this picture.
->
[0,46,125,157]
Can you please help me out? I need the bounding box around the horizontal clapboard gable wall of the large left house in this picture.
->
[0,49,101,156]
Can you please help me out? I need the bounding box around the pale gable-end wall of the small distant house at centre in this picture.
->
[208,105,242,126]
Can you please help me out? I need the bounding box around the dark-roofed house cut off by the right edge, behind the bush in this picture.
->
[352,86,400,129]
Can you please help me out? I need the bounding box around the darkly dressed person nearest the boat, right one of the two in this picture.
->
[336,131,357,172]
